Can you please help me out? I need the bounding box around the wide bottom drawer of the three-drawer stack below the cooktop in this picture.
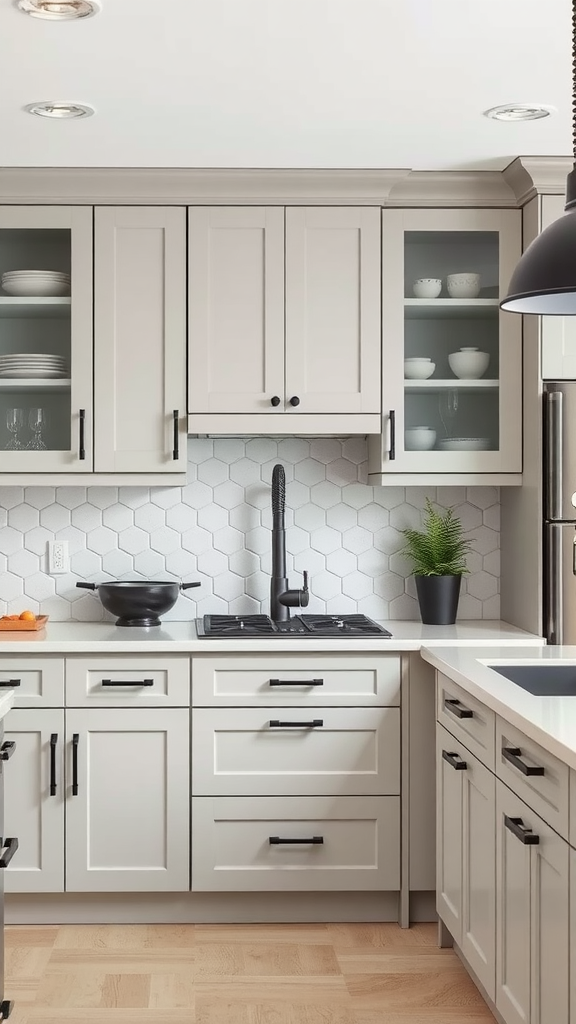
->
[192,797,400,892]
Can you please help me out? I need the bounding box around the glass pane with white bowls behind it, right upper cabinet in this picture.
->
[404,231,500,452]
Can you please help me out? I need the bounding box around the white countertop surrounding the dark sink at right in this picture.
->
[420,644,576,769]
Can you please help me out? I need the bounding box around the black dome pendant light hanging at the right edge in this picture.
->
[500,0,576,316]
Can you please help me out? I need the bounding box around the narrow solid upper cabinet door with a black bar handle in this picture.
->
[94,207,187,473]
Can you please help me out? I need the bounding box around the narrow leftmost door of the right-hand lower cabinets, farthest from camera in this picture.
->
[436,725,466,945]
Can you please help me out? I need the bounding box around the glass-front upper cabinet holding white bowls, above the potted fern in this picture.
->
[371,209,522,474]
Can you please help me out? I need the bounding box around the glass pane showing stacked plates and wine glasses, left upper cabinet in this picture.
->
[0,228,72,456]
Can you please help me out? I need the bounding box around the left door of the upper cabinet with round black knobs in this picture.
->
[189,207,284,414]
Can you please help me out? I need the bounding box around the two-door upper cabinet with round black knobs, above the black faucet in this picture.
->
[189,207,380,433]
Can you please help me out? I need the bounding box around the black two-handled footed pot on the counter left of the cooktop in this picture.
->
[76,581,200,626]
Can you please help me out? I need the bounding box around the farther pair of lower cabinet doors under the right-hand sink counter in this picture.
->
[437,725,496,998]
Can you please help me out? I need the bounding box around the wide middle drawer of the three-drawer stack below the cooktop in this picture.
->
[192,707,400,797]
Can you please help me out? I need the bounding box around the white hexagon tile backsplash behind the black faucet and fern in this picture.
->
[0,437,500,621]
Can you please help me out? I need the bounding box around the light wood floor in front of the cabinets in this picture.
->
[5,925,494,1024]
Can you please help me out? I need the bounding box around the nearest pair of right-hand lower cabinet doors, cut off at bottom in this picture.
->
[495,780,570,1024]
